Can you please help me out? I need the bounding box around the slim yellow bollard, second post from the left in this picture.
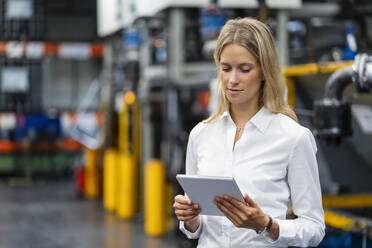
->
[103,149,118,211]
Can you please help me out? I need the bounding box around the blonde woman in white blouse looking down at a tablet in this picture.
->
[173,18,324,248]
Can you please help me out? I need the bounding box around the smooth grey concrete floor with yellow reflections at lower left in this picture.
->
[0,181,192,248]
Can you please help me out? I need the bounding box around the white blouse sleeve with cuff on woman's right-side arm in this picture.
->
[266,129,325,247]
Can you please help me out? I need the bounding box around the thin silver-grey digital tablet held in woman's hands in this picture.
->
[176,174,245,216]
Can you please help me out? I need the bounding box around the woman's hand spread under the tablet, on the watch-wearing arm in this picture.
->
[214,194,269,231]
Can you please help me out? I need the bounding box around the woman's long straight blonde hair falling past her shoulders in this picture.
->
[203,18,297,123]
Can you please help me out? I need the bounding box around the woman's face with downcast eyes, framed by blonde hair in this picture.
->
[219,43,263,109]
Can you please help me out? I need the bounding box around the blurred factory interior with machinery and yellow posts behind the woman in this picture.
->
[0,0,372,248]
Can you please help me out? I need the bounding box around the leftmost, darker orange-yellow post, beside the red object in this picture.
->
[85,148,100,199]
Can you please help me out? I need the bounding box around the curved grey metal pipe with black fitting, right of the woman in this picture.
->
[313,54,372,145]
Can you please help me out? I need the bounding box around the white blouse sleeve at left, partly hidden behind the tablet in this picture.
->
[179,128,203,239]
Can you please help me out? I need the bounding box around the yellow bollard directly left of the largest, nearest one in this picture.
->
[116,153,138,219]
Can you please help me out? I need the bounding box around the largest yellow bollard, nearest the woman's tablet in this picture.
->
[145,160,166,236]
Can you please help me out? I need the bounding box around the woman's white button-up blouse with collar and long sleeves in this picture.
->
[180,107,325,248]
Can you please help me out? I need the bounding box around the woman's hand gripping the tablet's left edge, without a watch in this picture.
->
[173,195,201,232]
